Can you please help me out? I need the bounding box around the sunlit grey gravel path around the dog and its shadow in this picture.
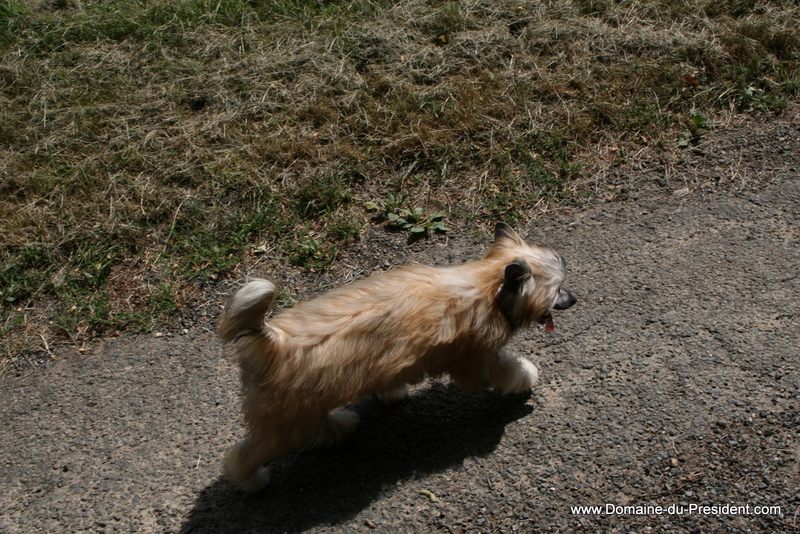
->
[0,121,800,534]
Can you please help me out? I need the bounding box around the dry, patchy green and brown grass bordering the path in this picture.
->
[0,0,800,366]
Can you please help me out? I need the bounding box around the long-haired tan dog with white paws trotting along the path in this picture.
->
[219,223,577,491]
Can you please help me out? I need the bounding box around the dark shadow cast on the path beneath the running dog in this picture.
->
[180,384,532,534]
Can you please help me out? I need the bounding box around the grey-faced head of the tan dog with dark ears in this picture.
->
[486,223,577,332]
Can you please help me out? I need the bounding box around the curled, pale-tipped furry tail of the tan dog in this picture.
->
[219,278,277,343]
